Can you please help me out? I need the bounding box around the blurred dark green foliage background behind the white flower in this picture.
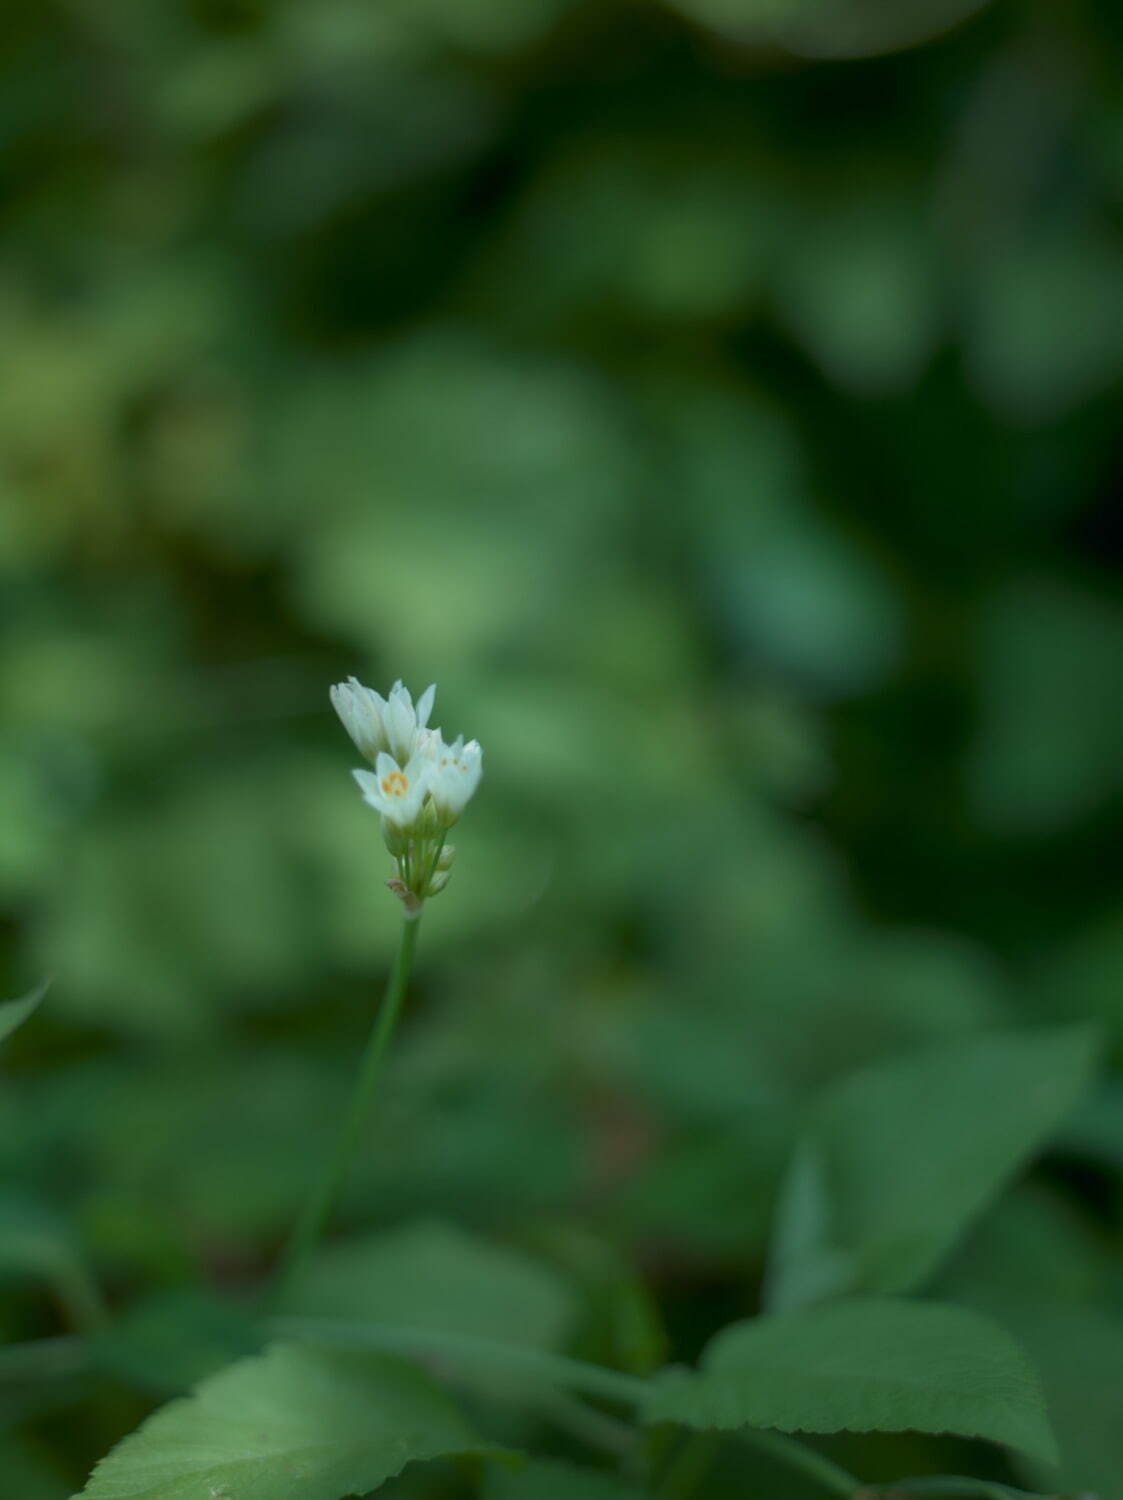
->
[0,0,1123,1496]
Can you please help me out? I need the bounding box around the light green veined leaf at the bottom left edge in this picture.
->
[73,1344,498,1500]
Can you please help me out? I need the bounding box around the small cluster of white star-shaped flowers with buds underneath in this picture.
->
[331,677,483,915]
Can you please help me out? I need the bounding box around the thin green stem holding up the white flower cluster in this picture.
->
[270,912,421,1305]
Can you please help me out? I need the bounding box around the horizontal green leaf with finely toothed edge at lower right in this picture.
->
[643,1298,1057,1463]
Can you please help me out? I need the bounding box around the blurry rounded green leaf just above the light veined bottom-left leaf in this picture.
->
[285,1223,574,1349]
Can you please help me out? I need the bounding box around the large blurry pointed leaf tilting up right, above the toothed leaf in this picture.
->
[766,1026,1096,1310]
